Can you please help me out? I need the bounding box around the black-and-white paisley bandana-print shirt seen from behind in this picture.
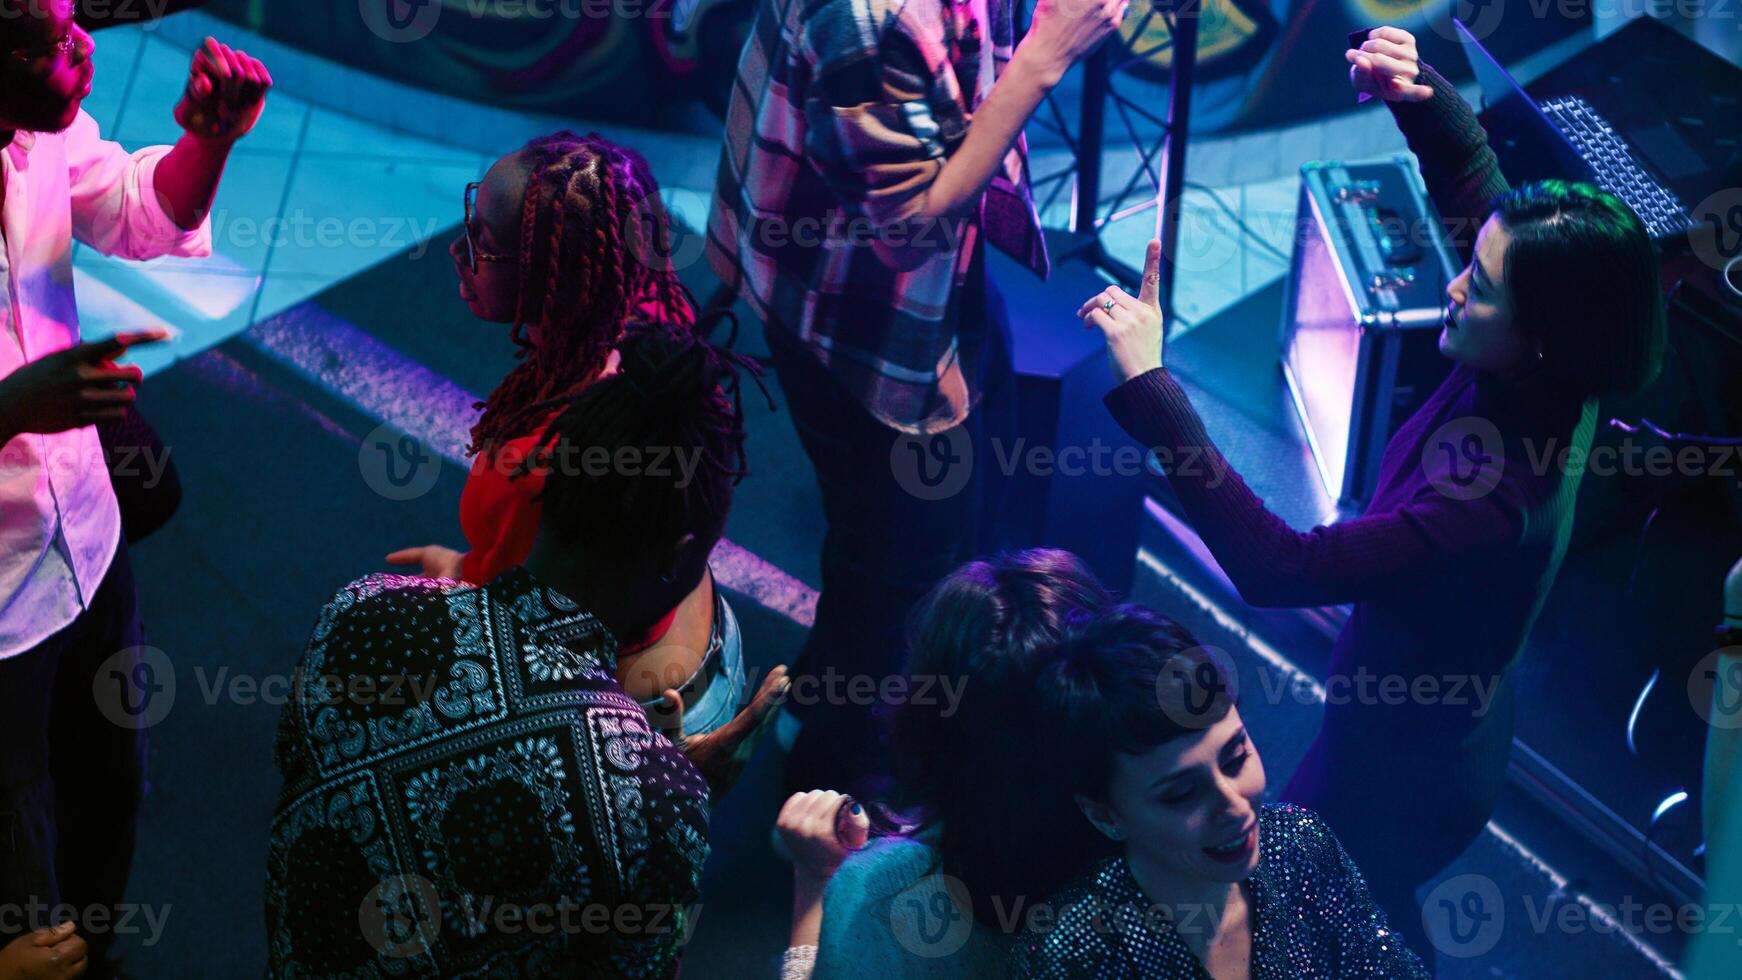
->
[267,567,707,978]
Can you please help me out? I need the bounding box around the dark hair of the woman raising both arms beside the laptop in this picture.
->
[1495,181,1667,397]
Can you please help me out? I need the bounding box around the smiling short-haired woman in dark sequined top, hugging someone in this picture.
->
[1009,606,1428,980]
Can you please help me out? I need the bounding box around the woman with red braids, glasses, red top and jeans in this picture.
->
[387,131,762,765]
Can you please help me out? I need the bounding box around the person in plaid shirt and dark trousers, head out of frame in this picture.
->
[707,0,1125,789]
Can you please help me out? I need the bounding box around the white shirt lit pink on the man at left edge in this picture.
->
[0,111,211,658]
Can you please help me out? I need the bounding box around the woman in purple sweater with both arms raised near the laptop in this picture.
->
[1077,28,1665,954]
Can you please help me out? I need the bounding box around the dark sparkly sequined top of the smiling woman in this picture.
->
[1010,804,1428,980]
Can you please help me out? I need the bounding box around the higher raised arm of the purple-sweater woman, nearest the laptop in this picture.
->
[1345,28,1507,261]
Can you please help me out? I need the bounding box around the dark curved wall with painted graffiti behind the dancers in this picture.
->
[204,0,1588,132]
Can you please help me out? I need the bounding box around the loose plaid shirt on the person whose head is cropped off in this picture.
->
[707,0,1047,433]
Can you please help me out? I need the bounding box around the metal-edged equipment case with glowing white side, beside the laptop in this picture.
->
[1282,157,1460,503]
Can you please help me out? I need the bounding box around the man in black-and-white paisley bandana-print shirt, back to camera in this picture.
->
[267,327,762,978]
